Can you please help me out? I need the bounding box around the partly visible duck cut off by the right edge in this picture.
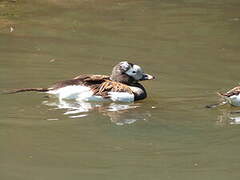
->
[206,86,240,108]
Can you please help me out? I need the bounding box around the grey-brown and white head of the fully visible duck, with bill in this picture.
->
[110,61,155,85]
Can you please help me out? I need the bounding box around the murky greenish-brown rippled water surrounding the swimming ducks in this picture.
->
[0,0,240,180]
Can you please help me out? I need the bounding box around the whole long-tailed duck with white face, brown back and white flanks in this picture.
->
[8,61,155,102]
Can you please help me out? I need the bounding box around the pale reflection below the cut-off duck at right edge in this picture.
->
[217,108,240,125]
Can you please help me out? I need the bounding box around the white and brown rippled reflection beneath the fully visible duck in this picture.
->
[43,99,151,125]
